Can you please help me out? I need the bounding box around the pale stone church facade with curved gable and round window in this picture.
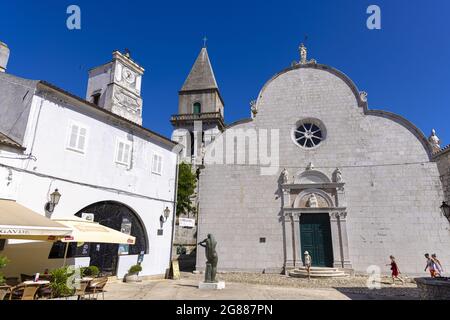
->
[193,47,450,274]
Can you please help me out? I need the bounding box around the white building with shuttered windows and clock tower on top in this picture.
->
[0,43,177,278]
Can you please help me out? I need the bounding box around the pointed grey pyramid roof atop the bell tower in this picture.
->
[181,47,218,91]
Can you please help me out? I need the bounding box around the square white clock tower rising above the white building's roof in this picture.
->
[86,51,144,125]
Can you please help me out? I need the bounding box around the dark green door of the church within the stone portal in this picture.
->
[300,213,333,267]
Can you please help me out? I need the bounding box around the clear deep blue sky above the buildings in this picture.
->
[0,0,450,145]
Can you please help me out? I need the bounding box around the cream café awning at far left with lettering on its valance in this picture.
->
[0,200,72,241]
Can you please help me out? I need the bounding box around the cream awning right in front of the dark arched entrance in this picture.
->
[53,217,136,245]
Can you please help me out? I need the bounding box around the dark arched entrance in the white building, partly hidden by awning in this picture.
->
[75,201,148,275]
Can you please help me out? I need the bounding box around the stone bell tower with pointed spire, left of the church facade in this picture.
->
[171,46,225,165]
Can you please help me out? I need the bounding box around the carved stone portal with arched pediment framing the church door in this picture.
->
[281,169,352,270]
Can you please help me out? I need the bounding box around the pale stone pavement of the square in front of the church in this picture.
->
[105,273,419,300]
